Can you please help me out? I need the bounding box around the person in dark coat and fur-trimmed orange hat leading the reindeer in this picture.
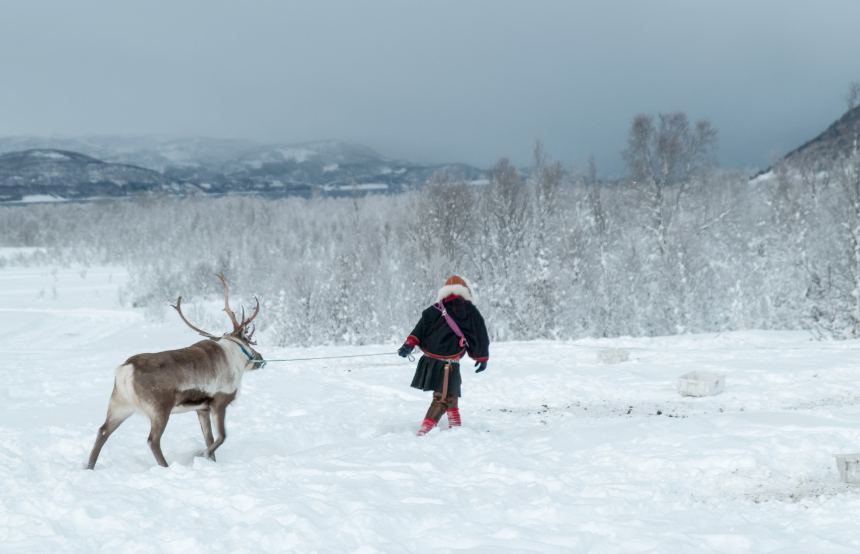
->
[397,275,490,437]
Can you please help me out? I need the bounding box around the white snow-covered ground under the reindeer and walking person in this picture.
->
[0,267,860,553]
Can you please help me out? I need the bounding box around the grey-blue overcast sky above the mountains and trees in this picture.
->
[0,0,860,175]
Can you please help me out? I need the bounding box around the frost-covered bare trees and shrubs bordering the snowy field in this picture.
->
[0,112,860,345]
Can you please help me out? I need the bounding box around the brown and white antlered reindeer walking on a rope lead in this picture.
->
[87,275,263,469]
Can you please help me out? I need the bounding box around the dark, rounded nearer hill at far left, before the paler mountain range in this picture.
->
[0,148,182,201]
